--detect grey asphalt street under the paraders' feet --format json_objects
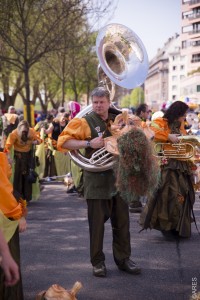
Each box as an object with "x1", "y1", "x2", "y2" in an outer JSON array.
[{"x1": 20, "y1": 183, "x2": 200, "y2": 300}]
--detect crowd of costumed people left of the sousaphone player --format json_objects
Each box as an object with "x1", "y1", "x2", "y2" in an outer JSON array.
[{"x1": 0, "y1": 101, "x2": 81, "y2": 300}]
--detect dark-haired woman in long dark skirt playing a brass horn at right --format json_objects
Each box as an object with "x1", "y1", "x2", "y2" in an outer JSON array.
[{"x1": 140, "y1": 101, "x2": 195, "y2": 237}]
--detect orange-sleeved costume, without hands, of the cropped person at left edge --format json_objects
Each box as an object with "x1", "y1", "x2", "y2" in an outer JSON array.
[{"x1": 0, "y1": 152, "x2": 26, "y2": 300}]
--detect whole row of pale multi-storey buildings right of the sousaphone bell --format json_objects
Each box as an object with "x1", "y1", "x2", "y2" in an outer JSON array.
[{"x1": 145, "y1": 0, "x2": 200, "y2": 110}]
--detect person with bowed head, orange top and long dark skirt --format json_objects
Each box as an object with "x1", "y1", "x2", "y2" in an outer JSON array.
[{"x1": 4, "y1": 120, "x2": 42, "y2": 201}]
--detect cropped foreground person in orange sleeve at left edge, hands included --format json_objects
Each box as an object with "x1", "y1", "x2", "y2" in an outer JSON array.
[{"x1": 0, "y1": 152, "x2": 27, "y2": 300}]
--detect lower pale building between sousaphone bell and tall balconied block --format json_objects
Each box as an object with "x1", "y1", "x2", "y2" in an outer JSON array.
[{"x1": 144, "y1": 34, "x2": 180, "y2": 110}]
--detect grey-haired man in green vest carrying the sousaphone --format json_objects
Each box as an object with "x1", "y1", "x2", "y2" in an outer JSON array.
[{"x1": 58, "y1": 87, "x2": 141, "y2": 277}]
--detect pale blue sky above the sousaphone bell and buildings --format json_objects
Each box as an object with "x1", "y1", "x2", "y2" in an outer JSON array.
[{"x1": 100, "y1": 0, "x2": 182, "y2": 60}]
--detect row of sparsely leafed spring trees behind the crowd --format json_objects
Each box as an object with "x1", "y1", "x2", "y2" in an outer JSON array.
[{"x1": 0, "y1": 0, "x2": 115, "y2": 123}]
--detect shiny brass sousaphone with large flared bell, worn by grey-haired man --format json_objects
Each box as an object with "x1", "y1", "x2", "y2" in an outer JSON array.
[{"x1": 69, "y1": 23, "x2": 149, "y2": 172}]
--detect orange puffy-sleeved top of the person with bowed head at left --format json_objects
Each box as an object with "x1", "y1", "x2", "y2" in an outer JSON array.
[{"x1": 4, "y1": 128, "x2": 42, "y2": 152}]
